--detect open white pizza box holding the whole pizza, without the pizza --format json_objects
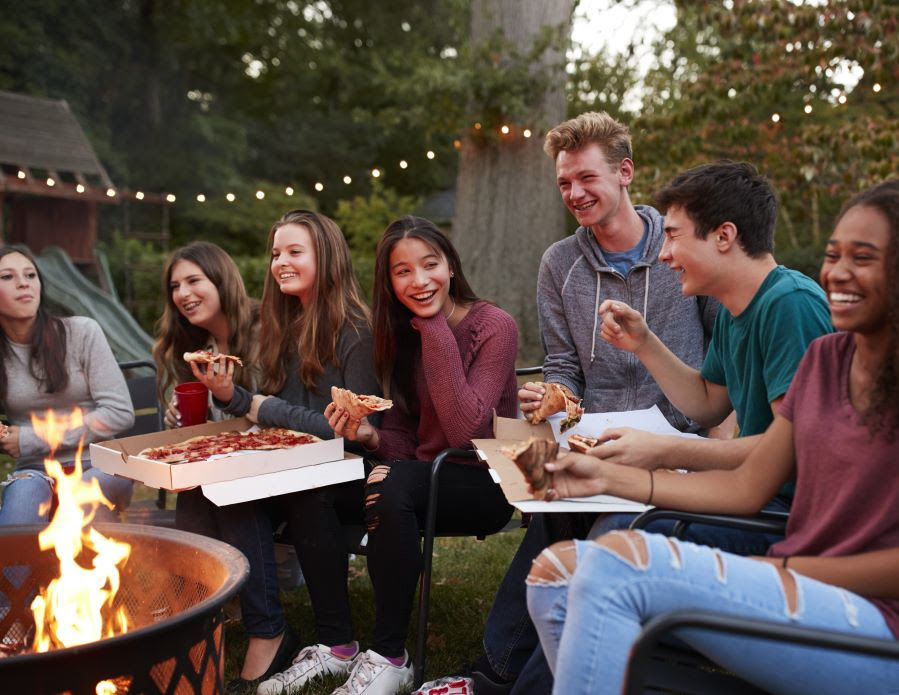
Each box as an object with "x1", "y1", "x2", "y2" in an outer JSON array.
[{"x1": 91, "y1": 418, "x2": 344, "y2": 492}]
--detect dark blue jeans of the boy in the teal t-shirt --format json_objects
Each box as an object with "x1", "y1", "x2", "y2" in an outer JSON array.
[{"x1": 484, "y1": 497, "x2": 789, "y2": 695}]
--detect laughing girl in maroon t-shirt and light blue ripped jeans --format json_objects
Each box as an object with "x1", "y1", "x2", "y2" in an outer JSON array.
[{"x1": 528, "y1": 180, "x2": 899, "y2": 695}]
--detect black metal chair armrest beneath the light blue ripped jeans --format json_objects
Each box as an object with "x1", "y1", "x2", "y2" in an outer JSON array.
[{"x1": 625, "y1": 611, "x2": 899, "y2": 695}]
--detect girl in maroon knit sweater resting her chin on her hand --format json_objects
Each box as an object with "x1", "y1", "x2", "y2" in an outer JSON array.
[{"x1": 325, "y1": 216, "x2": 518, "y2": 695}]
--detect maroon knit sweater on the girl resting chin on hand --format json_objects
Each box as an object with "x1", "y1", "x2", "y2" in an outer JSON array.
[{"x1": 376, "y1": 301, "x2": 518, "y2": 468}]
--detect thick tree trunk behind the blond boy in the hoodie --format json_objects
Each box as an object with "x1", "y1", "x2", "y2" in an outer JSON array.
[{"x1": 453, "y1": 0, "x2": 575, "y2": 364}]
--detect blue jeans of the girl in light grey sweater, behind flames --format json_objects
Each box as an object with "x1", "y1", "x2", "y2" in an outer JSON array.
[{"x1": 0, "y1": 462, "x2": 133, "y2": 526}]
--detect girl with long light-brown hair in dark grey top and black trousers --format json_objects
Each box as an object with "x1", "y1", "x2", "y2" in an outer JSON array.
[{"x1": 194, "y1": 210, "x2": 380, "y2": 693}]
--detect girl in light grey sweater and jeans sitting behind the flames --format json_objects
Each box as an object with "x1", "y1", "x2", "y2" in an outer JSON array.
[{"x1": 0, "y1": 246, "x2": 134, "y2": 525}]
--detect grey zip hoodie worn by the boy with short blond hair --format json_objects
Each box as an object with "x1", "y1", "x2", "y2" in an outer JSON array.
[{"x1": 537, "y1": 205, "x2": 718, "y2": 431}]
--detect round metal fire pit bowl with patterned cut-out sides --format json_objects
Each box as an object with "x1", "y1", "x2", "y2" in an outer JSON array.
[{"x1": 0, "y1": 524, "x2": 248, "y2": 695}]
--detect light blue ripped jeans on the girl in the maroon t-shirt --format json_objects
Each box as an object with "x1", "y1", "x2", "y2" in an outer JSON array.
[{"x1": 528, "y1": 531, "x2": 899, "y2": 695}]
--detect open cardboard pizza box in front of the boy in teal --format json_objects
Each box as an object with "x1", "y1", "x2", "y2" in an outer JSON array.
[{"x1": 472, "y1": 412, "x2": 650, "y2": 514}]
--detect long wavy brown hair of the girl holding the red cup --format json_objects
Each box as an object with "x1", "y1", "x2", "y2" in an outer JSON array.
[{"x1": 153, "y1": 241, "x2": 259, "y2": 400}]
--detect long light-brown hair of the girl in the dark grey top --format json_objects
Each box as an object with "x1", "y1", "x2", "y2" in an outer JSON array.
[{"x1": 259, "y1": 210, "x2": 371, "y2": 393}]
